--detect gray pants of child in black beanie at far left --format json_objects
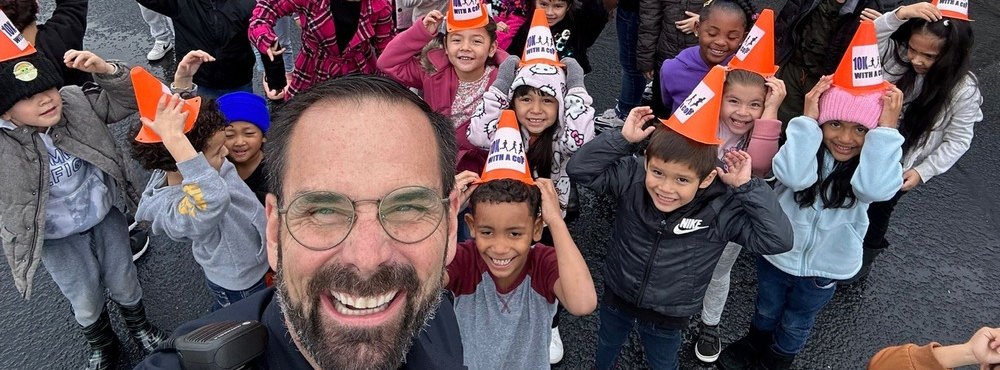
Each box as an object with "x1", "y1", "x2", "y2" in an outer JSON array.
[{"x1": 42, "y1": 207, "x2": 142, "y2": 326}]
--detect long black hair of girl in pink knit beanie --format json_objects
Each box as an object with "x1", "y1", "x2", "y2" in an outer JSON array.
[{"x1": 795, "y1": 146, "x2": 861, "y2": 208}]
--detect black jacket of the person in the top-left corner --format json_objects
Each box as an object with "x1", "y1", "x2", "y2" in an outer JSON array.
[{"x1": 35, "y1": 0, "x2": 94, "y2": 86}]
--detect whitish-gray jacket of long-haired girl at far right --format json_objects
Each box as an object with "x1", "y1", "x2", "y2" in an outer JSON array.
[{"x1": 875, "y1": 10, "x2": 983, "y2": 183}]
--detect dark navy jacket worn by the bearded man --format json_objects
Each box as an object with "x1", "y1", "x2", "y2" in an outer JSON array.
[{"x1": 135, "y1": 288, "x2": 465, "y2": 370}]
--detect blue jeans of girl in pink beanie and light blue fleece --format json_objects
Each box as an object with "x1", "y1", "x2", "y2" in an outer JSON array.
[{"x1": 752, "y1": 256, "x2": 837, "y2": 355}]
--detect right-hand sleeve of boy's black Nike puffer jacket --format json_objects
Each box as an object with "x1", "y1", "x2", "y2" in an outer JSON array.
[{"x1": 724, "y1": 177, "x2": 794, "y2": 254}]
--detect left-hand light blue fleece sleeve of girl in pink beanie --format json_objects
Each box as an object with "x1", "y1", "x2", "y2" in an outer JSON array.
[{"x1": 771, "y1": 116, "x2": 823, "y2": 191}]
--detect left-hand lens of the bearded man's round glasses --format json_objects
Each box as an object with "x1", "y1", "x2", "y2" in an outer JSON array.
[{"x1": 285, "y1": 192, "x2": 354, "y2": 250}]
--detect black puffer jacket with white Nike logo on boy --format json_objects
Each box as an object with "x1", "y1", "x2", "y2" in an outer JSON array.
[{"x1": 567, "y1": 132, "x2": 793, "y2": 317}]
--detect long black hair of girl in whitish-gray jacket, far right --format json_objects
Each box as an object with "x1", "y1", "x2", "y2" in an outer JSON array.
[{"x1": 883, "y1": 18, "x2": 975, "y2": 153}]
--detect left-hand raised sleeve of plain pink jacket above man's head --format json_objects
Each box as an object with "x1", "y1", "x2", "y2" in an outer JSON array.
[{"x1": 377, "y1": 23, "x2": 435, "y2": 89}]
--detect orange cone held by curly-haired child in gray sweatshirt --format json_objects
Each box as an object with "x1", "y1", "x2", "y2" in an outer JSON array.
[{"x1": 130, "y1": 67, "x2": 201, "y2": 143}]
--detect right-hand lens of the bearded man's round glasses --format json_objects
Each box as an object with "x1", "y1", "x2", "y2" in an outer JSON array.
[{"x1": 379, "y1": 187, "x2": 444, "y2": 243}]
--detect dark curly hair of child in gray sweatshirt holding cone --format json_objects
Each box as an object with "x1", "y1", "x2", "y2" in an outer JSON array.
[{"x1": 129, "y1": 99, "x2": 228, "y2": 171}]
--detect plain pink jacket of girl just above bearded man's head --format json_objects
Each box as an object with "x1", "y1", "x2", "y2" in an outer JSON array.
[{"x1": 377, "y1": 23, "x2": 507, "y2": 173}]
